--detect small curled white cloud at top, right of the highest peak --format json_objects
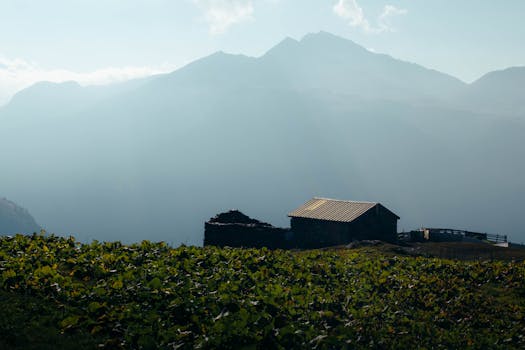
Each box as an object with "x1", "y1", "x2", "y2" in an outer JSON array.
[{"x1": 333, "y1": 0, "x2": 407, "y2": 34}]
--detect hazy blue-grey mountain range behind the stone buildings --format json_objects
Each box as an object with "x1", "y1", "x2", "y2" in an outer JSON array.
[{"x1": 0, "y1": 32, "x2": 525, "y2": 244}]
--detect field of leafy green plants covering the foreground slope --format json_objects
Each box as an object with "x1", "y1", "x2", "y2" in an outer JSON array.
[{"x1": 0, "y1": 235, "x2": 525, "y2": 349}]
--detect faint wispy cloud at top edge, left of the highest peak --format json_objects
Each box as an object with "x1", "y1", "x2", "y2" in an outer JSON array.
[{"x1": 193, "y1": 0, "x2": 253, "y2": 35}]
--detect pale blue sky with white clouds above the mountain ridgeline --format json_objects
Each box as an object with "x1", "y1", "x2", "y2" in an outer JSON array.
[{"x1": 0, "y1": 0, "x2": 525, "y2": 105}]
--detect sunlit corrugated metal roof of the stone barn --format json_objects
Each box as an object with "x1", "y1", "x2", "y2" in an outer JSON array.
[{"x1": 288, "y1": 197, "x2": 384, "y2": 222}]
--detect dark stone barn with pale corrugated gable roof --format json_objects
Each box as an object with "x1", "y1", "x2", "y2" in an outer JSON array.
[{"x1": 288, "y1": 198, "x2": 399, "y2": 249}]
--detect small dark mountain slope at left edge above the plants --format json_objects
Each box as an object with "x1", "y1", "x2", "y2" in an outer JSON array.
[{"x1": 0, "y1": 198, "x2": 40, "y2": 234}]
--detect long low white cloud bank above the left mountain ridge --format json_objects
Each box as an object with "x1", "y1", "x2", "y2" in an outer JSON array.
[{"x1": 0, "y1": 55, "x2": 175, "y2": 106}]
